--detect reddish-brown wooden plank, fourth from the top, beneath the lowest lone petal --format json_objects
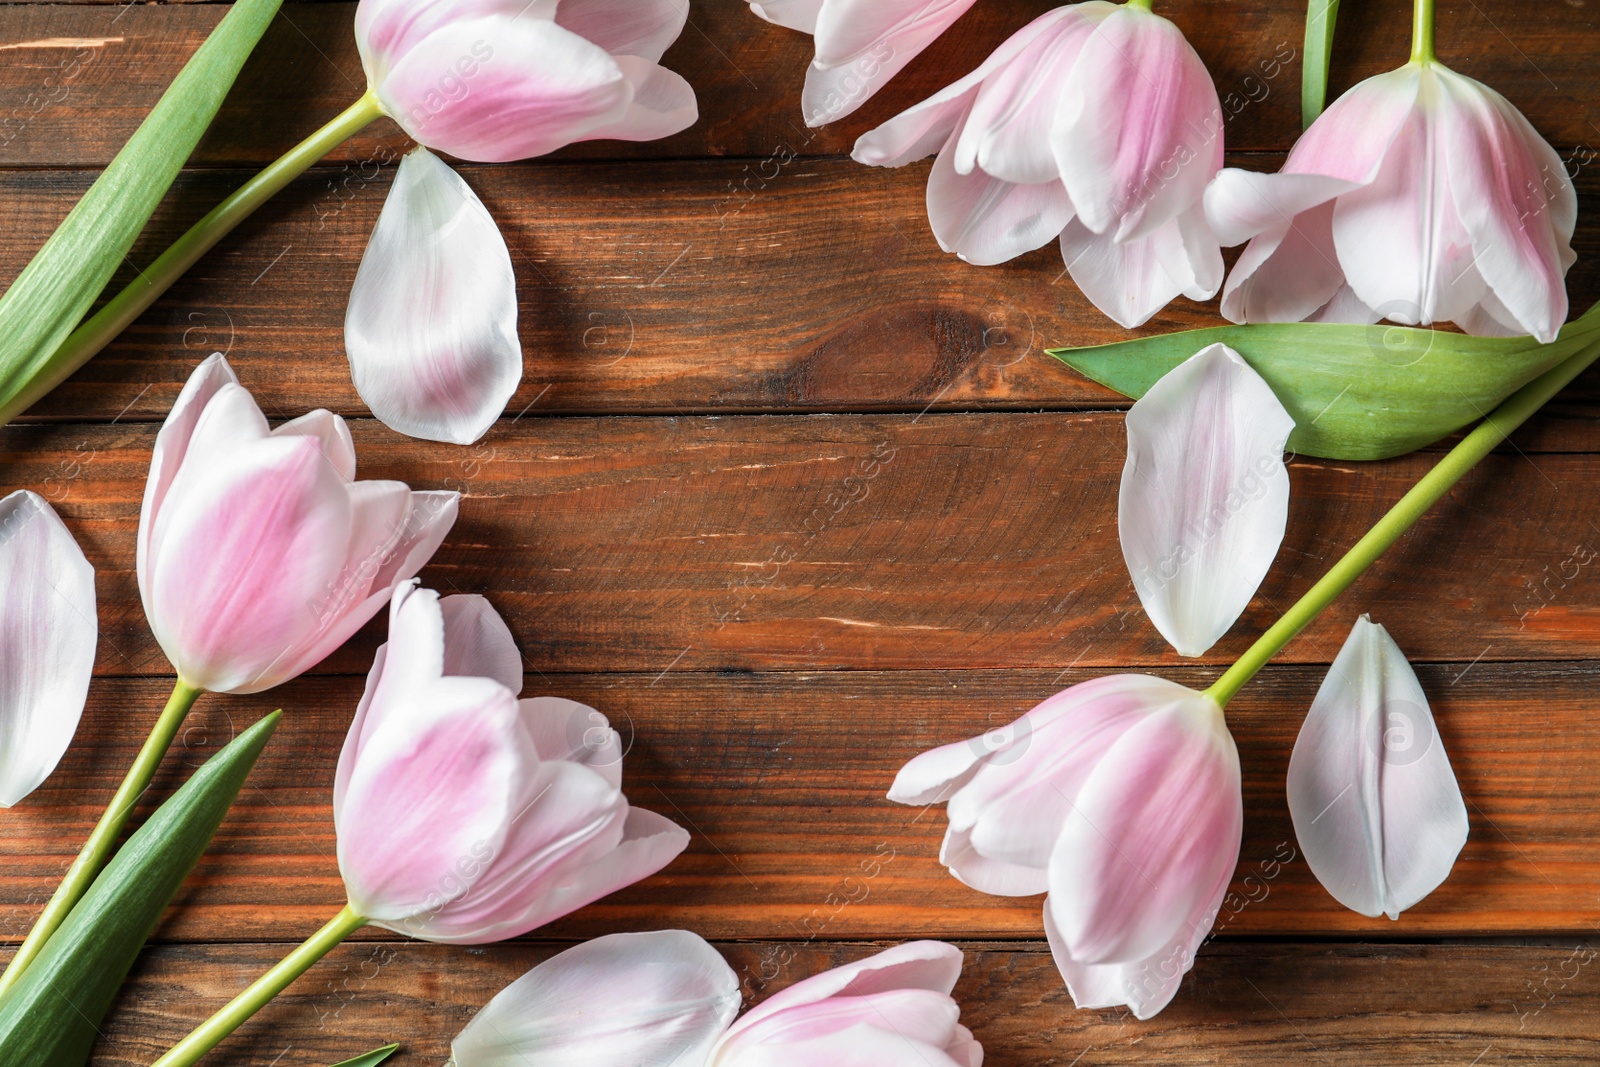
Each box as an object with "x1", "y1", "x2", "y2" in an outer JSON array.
[{"x1": 0, "y1": 661, "x2": 1600, "y2": 942}]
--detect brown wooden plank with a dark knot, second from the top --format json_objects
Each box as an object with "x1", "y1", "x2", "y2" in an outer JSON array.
[{"x1": 0, "y1": 164, "x2": 1600, "y2": 421}]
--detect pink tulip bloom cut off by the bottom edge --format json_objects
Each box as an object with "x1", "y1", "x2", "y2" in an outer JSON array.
[{"x1": 706, "y1": 941, "x2": 984, "y2": 1067}]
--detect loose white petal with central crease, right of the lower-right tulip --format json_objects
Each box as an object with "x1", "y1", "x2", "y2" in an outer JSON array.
[{"x1": 1288, "y1": 616, "x2": 1467, "y2": 918}]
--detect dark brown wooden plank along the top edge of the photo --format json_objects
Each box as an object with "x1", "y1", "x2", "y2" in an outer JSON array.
[{"x1": 0, "y1": 0, "x2": 1600, "y2": 166}]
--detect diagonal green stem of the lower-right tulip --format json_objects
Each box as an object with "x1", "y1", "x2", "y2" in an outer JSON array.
[{"x1": 1206, "y1": 342, "x2": 1600, "y2": 707}]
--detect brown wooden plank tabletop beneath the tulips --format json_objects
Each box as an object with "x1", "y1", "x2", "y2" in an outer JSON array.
[{"x1": 0, "y1": 0, "x2": 1600, "y2": 1067}]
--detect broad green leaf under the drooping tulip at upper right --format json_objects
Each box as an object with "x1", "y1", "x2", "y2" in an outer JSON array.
[{"x1": 1048, "y1": 306, "x2": 1600, "y2": 459}]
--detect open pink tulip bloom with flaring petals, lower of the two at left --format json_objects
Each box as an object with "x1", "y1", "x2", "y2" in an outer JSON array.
[{"x1": 333, "y1": 584, "x2": 688, "y2": 944}]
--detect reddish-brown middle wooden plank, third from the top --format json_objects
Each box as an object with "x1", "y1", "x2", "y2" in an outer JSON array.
[{"x1": 0, "y1": 412, "x2": 1600, "y2": 675}]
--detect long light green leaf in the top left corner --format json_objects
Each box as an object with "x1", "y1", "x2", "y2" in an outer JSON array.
[{"x1": 0, "y1": 0, "x2": 283, "y2": 422}]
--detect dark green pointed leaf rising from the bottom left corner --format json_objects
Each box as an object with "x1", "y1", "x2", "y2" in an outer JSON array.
[{"x1": 0, "y1": 712, "x2": 282, "y2": 1067}]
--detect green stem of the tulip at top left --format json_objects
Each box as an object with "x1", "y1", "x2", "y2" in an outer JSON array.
[{"x1": 0, "y1": 90, "x2": 382, "y2": 426}]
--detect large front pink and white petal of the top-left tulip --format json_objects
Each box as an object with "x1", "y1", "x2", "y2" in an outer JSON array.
[{"x1": 374, "y1": 18, "x2": 632, "y2": 163}]
